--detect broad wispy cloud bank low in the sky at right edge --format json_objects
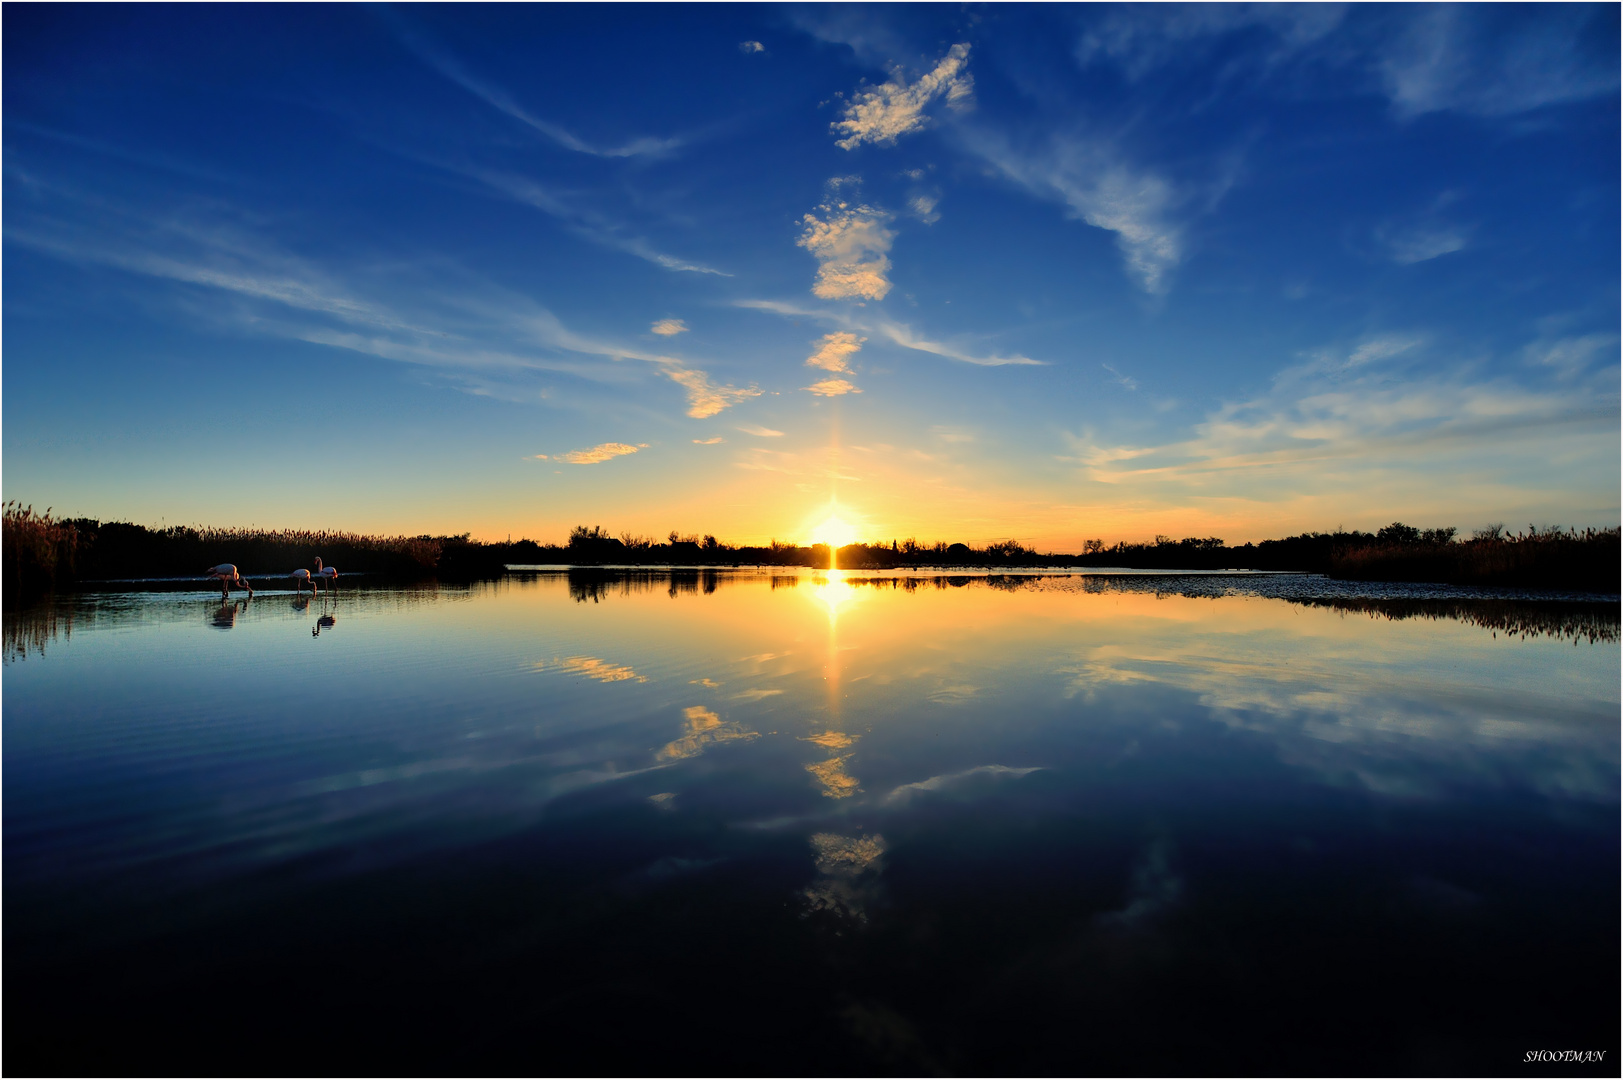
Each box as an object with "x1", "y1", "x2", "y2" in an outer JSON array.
[{"x1": 1068, "y1": 335, "x2": 1618, "y2": 528}]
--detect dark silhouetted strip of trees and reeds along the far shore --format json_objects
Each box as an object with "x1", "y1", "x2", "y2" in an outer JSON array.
[{"x1": 0, "y1": 502, "x2": 1620, "y2": 607}]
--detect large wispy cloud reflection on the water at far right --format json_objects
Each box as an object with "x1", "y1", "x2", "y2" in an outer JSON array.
[{"x1": 1068, "y1": 640, "x2": 1618, "y2": 799}]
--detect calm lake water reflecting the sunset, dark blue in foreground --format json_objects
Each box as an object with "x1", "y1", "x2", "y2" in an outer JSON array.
[{"x1": 3, "y1": 572, "x2": 1620, "y2": 1075}]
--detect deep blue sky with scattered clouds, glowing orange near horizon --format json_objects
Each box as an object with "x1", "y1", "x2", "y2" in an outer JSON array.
[{"x1": 0, "y1": 3, "x2": 1620, "y2": 551}]
